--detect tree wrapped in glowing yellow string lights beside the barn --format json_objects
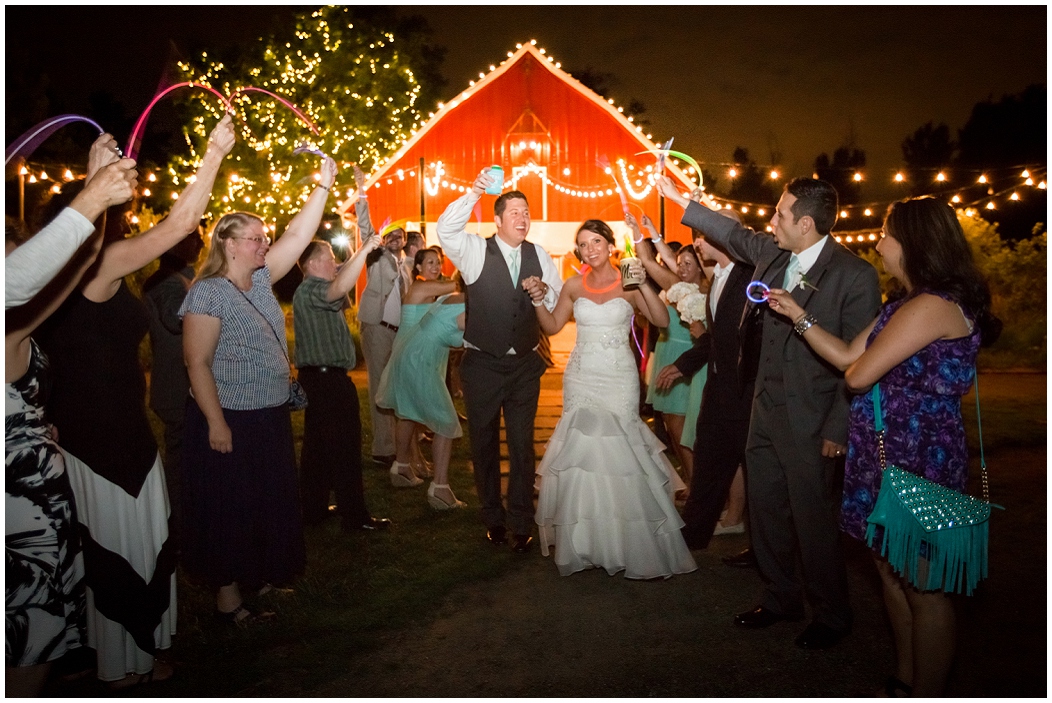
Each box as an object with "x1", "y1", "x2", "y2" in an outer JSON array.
[{"x1": 157, "y1": 7, "x2": 428, "y2": 227}]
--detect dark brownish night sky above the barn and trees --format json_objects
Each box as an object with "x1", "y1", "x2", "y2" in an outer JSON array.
[{"x1": 5, "y1": 5, "x2": 1047, "y2": 198}]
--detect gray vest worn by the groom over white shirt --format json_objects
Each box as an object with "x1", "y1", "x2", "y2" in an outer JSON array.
[{"x1": 464, "y1": 237, "x2": 542, "y2": 357}]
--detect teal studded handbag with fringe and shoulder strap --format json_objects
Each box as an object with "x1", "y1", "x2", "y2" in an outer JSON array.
[{"x1": 866, "y1": 378, "x2": 1000, "y2": 596}]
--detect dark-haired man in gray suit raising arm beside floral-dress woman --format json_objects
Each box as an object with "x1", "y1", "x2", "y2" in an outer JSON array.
[{"x1": 659, "y1": 178, "x2": 881, "y2": 649}]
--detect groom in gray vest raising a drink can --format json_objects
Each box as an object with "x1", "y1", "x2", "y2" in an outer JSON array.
[{"x1": 438, "y1": 168, "x2": 563, "y2": 553}]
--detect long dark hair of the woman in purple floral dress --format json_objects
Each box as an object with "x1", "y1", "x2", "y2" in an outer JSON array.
[{"x1": 884, "y1": 197, "x2": 1003, "y2": 346}]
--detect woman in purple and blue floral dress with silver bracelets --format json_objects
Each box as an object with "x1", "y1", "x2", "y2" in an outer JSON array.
[{"x1": 770, "y1": 198, "x2": 1000, "y2": 697}]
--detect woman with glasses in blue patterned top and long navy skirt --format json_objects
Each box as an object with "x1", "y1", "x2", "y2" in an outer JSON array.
[{"x1": 180, "y1": 158, "x2": 337, "y2": 624}]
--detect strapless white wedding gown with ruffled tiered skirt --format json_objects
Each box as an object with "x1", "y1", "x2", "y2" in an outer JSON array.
[{"x1": 537, "y1": 298, "x2": 697, "y2": 579}]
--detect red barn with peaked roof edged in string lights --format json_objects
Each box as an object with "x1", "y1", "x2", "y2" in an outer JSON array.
[{"x1": 343, "y1": 42, "x2": 696, "y2": 271}]
